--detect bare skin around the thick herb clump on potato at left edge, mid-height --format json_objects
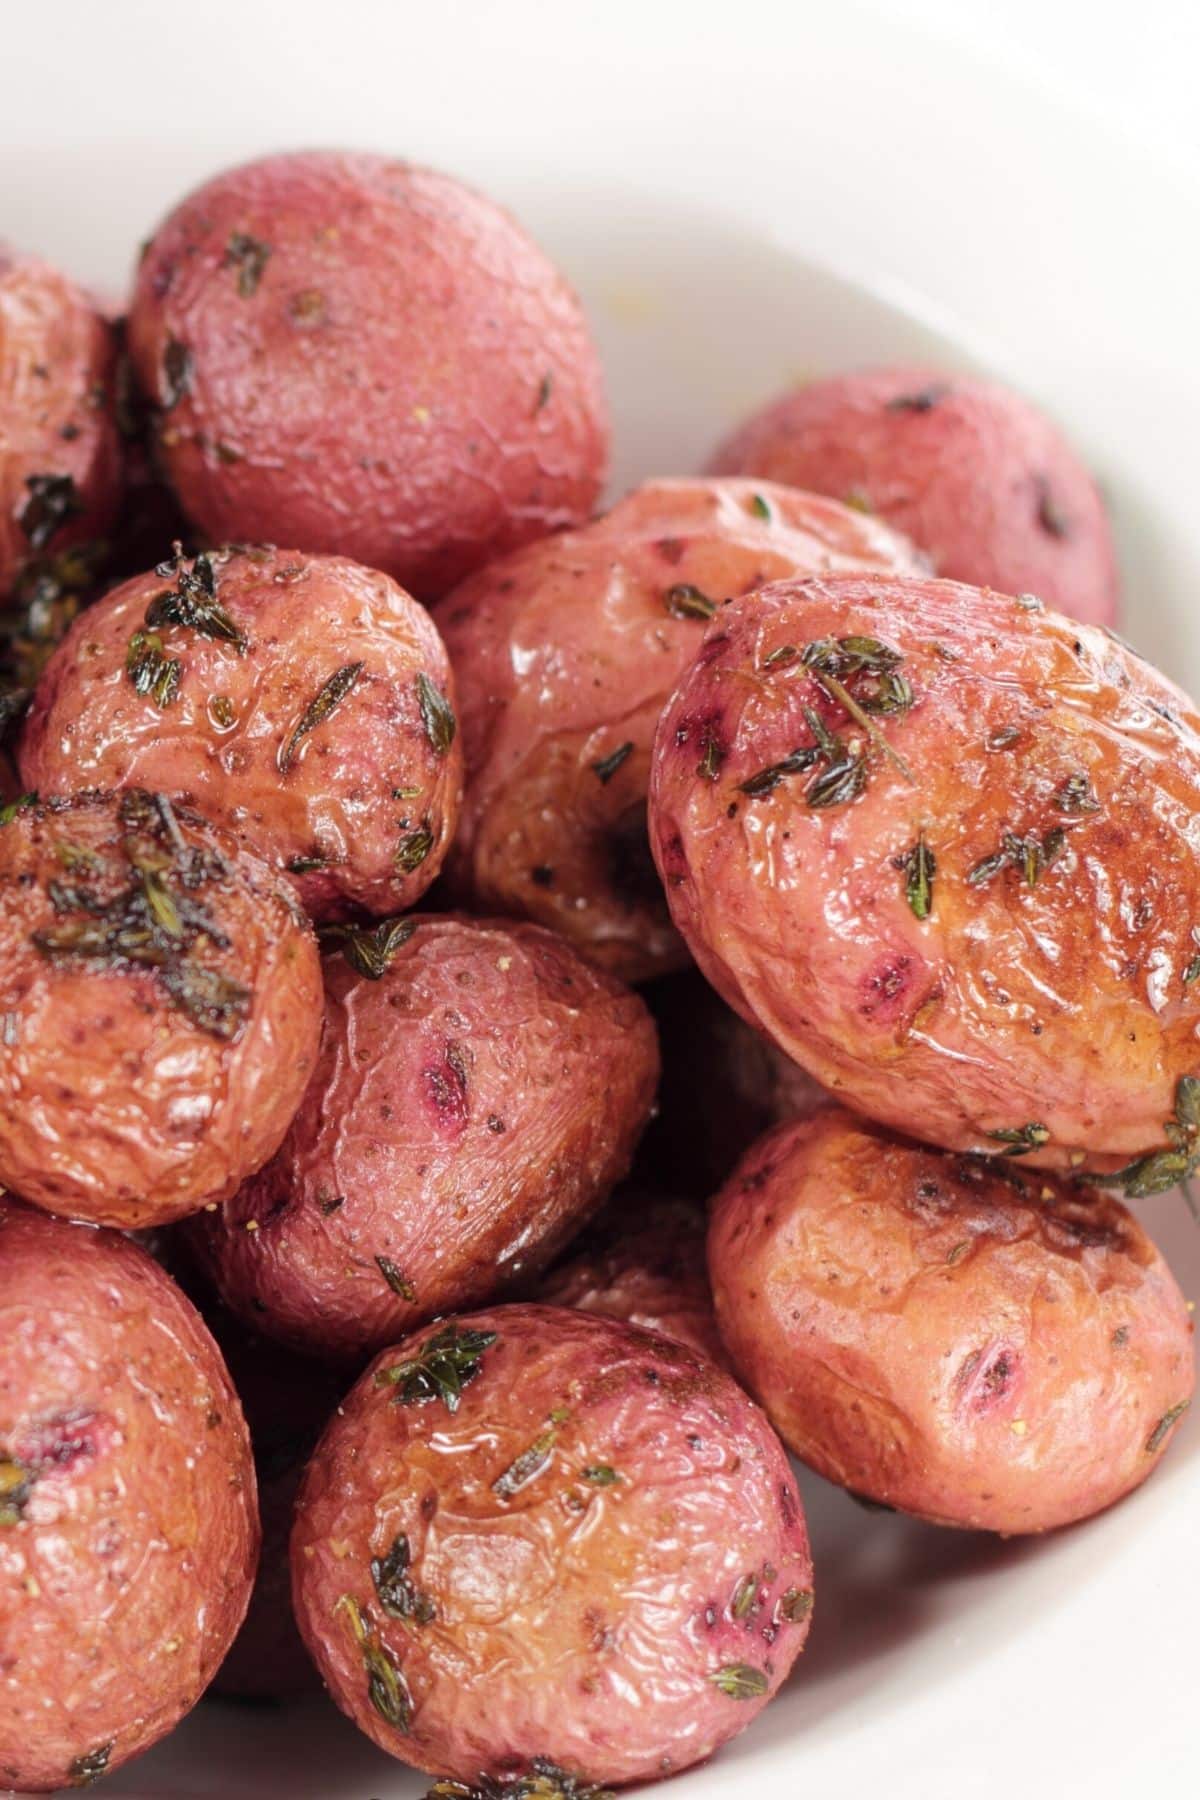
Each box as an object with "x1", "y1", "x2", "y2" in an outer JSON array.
[{"x1": 0, "y1": 794, "x2": 320, "y2": 1228}]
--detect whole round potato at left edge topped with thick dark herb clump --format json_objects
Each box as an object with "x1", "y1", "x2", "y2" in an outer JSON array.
[{"x1": 0, "y1": 788, "x2": 320, "y2": 1226}]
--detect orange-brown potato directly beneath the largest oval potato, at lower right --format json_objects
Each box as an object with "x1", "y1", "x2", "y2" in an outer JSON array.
[{"x1": 709, "y1": 1109, "x2": 1195, "y2": 1534}]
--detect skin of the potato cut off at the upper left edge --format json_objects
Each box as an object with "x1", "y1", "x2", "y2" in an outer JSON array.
[{"x1": 0, "y1": 245, "x2": 121, "y2": 601}]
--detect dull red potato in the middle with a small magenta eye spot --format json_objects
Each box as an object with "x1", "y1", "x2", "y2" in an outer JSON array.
[{"x1": 194, "y1": 914, "x2": 658, "y2": 1357}]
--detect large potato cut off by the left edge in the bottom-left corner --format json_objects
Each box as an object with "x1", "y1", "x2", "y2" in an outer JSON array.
[{"x1": 0, "y1": 1199, "x2": 259, "y2": 1793}]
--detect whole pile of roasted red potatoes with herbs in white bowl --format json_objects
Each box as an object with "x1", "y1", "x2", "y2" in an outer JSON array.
[{"x1": 0, "y1": 153, "x2": 1200, "y2": 1800}]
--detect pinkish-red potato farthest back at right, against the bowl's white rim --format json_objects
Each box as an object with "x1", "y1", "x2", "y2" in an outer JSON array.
[{"x1": 712, "y1": 365, "x2": 1119, "y2": 625}]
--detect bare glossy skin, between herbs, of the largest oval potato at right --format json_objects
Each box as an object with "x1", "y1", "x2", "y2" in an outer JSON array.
[{"x1": 651, "y1": 576, "x2": 1200, "y2": 1166}]
